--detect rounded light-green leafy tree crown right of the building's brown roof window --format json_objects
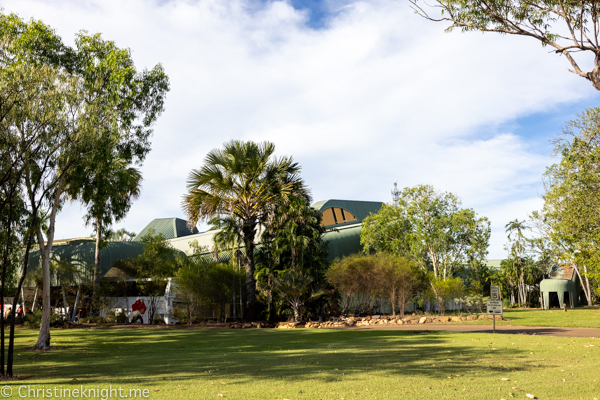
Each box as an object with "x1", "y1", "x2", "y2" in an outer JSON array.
[{"x1": 361, "y1": 185, "x2": 490, "y2": 280}]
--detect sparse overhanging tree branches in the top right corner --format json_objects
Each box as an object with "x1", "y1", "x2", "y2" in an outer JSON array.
[{"x1": 409, "y1": 0, "x2": 600, "y2": 90}]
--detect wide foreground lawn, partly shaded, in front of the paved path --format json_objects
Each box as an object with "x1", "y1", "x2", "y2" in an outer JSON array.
[{"x1": 8, "y1": 329, "x2": 600, "y2": 400}]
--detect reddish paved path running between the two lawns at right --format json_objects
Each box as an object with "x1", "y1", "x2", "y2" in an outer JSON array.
[{"x1": 342, "y1": 324, "x2": 600, "y2": 338}]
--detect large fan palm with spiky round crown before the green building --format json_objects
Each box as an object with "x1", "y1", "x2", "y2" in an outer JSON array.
[{"x1": 182, "y1": 140, "x2": 307, "y2": 319}]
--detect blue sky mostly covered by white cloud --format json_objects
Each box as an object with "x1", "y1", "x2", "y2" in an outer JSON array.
[{"x1": 0, "y1": 0, "x2": 600, "y2": 259}]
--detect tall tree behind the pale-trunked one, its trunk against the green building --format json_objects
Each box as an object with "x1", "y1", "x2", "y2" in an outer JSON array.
[{"x1": 68, "y1": 32, "x2": 169, "y2": 298}]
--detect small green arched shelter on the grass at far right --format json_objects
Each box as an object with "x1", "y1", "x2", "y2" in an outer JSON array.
[{"x1": 540, "y1": 264, "x2": 579, "y2": 310}]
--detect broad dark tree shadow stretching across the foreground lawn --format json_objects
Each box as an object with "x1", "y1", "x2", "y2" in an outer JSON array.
[{"x1": 9, "y1": 329, "x2": 530, "y2": 385}]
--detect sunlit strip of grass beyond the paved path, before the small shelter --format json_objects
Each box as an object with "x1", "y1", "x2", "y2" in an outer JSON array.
[{"x1": 462, "y1": 307, "x2": 600, "y2": 328}]
